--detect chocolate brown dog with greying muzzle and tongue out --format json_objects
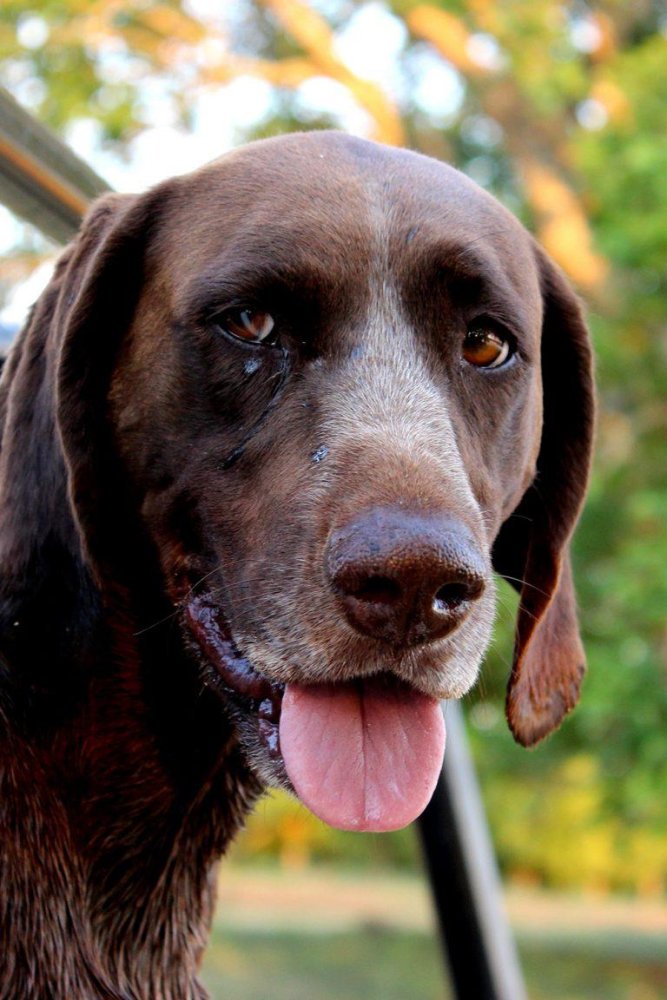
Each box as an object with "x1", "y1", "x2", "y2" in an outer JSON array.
[{"x1": 0, "y1": 132, "x2": 594, "y2": 1000}]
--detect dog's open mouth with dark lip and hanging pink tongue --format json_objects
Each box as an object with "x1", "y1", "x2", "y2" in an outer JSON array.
[{"x1": 185, "y1": 595, "x2": 445, "y2": 832}]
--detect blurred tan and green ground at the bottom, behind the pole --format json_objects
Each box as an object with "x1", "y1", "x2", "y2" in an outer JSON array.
[{"x1": 204, "y1": 865, "x2": 667, "y2": 1000}]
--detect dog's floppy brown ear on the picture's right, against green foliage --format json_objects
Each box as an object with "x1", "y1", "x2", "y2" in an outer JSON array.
[{"x1": 493, "y1": 247, "x2": 595, "y2": 746}]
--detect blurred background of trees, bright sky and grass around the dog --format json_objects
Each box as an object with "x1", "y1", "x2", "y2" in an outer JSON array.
[{"x1": 0, "y1": 0, "x2": 667, "y2": 1000}]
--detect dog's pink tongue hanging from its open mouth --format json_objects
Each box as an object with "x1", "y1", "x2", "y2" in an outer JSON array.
[{"x1": 280, "y1": 678, "x2": 445, "y2": 831}]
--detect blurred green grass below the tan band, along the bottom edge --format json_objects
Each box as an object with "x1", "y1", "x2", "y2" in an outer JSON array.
[{"x1": 204, "y1": 926, "x2": 667, "y2": 1000}]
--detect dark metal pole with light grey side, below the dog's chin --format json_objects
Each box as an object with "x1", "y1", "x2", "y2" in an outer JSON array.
[{"x1": 418, "y1": 702, "x2": 526, "y2": 1000}]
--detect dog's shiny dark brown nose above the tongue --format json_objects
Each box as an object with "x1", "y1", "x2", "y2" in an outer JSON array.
[{"x1": 325, "y1": 508, "x2": 486, "y2": 646}]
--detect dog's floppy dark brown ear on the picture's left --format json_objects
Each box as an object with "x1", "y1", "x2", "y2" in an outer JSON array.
[{"x1": 56, "y1": 188, "x2": 162, "y2": 583}]
